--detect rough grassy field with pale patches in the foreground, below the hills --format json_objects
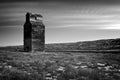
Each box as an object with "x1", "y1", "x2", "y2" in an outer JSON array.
[{"x1": 0, "y1": 51, "x2": 120, "y2": 80}]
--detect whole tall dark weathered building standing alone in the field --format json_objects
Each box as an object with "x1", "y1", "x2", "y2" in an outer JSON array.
[{"x1": 24, "y1": 12, "x2": 45, "y2": 52}]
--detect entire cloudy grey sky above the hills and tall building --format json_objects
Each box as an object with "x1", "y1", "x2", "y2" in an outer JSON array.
[{"x1": 0, "y1": 0, "x2": 120, "y2": 46}]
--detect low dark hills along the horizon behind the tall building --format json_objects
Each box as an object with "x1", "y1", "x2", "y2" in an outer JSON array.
[{"x1": 0, "y1": 38, "x2": 120, "y2": 51}]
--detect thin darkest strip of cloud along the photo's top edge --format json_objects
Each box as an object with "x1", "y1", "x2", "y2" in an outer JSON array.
[{"x1": 0, "y1": 0, "x2": 120, "y2": 4}]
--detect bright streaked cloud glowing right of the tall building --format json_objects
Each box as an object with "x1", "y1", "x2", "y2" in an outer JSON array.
[{"x1": 46, "y1": 6, "x2": 120, "y2": 30}]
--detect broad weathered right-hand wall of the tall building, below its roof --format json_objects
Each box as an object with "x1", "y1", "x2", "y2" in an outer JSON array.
[{"x1": 32, "y1": 22, "x2": 45, "y2": 51}]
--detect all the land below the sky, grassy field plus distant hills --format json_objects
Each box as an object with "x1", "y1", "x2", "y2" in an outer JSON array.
[{"x1": 0, "y1": 39, "x2": 120, "y2": 80}]
